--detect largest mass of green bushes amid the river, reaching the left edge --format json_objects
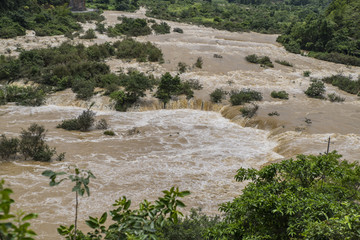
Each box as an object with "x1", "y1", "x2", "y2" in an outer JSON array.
[{"x1": 0, "y1": 38, "x2": 163, "y2": 102}]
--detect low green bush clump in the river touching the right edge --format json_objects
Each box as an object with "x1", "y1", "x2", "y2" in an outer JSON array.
[{"x1": 322, "y1": 74, "x2": 360, "y2": 94}]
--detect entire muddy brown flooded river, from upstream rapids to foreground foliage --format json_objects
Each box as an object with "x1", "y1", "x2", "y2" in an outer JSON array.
[{"x1": 0, "y1": 7, "x2": 360, "y2": 240}]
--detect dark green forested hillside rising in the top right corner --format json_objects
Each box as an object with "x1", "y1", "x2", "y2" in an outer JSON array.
[{"x1": 278, "y1": 0, "x2": 360, "y2": 66}]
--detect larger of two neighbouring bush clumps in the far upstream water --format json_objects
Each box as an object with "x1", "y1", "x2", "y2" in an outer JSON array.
[{"x1": 107, "y1": 17, "x2": 151, "y2": 37}]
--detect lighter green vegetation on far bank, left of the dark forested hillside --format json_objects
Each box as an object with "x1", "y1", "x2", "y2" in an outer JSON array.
[{"x1": 142, "y1": 0, "x2": 329, "y2": 33}]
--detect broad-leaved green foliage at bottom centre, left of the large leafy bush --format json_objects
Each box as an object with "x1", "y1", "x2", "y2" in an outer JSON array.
[{"x1": 58, "y1": 187, "x2": 190, "y2": 240}]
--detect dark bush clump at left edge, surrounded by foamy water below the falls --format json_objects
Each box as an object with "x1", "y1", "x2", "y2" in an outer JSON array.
[{"x1": 0, "y1": 124, "x2": 65, "y2": 162}]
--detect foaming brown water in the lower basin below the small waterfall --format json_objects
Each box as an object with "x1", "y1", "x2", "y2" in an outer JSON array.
[{"x1": 0, "y1": 106, "x2": 281, "y2": 239}]
